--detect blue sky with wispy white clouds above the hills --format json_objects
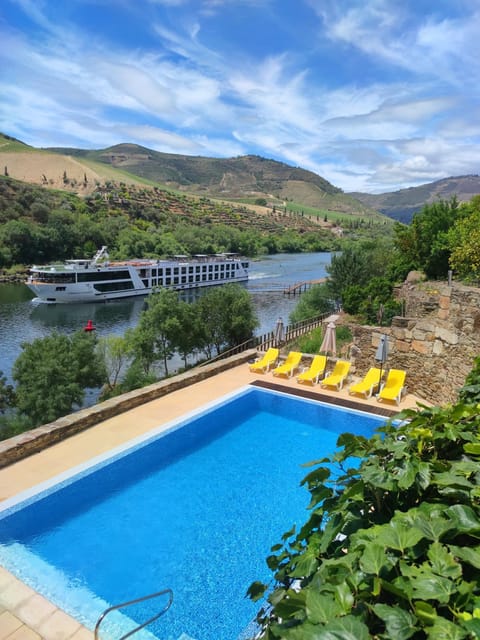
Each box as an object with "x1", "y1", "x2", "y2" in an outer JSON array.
[{"x1": 0, "y1": 0, "x2": 480, "y2": 193}]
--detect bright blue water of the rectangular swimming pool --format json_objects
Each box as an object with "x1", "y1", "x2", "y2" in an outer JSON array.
[{"x1": 0, "y1": 388, "x2": 384, "y2": 640}]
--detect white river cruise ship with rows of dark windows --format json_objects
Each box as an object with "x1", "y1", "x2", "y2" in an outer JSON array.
[{"x1": 26, "y1": 247, "x2": 249, "y2": 303}]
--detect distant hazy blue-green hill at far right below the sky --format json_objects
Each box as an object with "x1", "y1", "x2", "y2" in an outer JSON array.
[{"x1": 350, "y1": 175, "x2": 480, "y2": 223}]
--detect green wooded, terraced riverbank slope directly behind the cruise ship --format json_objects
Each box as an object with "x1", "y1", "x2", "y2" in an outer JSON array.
[{"x1": 0, "y1": 176, "x2": 339, "y2": 268}]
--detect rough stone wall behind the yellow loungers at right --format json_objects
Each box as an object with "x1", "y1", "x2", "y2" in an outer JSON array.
[{"x1": 351, "y1": 282, "x2": 480, "y2": 404}]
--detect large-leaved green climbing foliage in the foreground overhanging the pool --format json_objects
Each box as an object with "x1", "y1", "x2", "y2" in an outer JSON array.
[{"x1": 249, "y1": 384, "x2": 480, "y2": 640}]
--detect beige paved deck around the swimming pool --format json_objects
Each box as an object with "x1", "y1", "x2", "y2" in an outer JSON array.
[{"x1": 0, "y1": 364, "x2": 428, "y2": 640}]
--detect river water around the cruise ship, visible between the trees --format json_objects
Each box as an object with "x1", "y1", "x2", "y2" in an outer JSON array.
[{"x1": 0, "y1": 253, "x2": 331, "y2": 382}]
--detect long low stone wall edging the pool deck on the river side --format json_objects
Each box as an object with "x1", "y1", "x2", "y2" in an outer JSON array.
[{"x1": 0, "y1": 349, "x2": 257, "y2": 468}]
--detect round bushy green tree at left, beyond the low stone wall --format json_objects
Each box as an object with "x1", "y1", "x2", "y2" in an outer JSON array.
[{"x1": 12, "y1": 331, "x2": 104, "y2": 426}]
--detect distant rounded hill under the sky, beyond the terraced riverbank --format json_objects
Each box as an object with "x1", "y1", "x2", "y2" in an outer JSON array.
[{"x1": 48, "y1": 143, "x2": 378, "y2": 218}]
